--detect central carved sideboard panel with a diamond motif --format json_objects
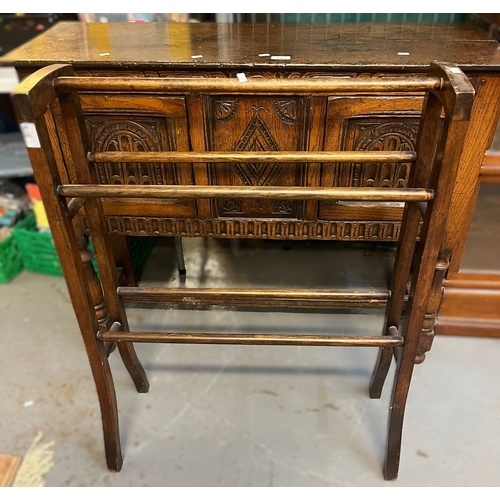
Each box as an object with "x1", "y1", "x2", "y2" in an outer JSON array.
[{"x1": 205, "y1": 96, "x2": 310, "y2": 218}]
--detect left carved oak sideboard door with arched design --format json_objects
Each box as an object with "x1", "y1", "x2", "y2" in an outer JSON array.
[{"x1": 82, "y1": 94, "x2": 196, "y2": 217}]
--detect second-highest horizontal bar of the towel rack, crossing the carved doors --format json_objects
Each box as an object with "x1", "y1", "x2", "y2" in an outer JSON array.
[{"x1": 87, "y1": 151, "x2": 417, "y2": 163}]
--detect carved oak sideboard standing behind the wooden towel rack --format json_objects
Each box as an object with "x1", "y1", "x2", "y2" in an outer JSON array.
[{"x1": 0, "y1": 22, "x2": 500, "y2": 336}]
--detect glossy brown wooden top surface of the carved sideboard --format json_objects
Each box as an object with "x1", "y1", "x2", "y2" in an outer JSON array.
[{"x1": 0, "y1": 22, "x2": 500, "y2": 71}]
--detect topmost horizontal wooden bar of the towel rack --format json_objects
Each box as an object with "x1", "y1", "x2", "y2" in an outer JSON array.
[{"x1": 54, "y1": 76, "x2": 442, "y2": 95}]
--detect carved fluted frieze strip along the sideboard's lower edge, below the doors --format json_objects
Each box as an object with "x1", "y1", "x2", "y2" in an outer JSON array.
[{"x1": 106, "y1": 216, "x2": 400, "y2": 241}]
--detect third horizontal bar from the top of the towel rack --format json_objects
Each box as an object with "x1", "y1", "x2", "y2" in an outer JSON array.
[{"x1": 57, "y1": 184, "x2": 434, "y2": 201}]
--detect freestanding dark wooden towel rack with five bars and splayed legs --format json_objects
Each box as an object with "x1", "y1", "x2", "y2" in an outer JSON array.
[{"x1": 13, "y1": 63, "x2": 474, "y2": 480}]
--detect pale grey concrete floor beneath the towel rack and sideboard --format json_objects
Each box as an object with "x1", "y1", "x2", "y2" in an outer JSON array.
[{"x1": 0, "y1": 239, "x2": 500, "y2": 486}]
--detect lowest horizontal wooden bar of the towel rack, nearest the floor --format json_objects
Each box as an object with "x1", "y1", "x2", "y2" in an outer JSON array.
[{"x1": 97, "y1": 331, "x2": 403, "y2": 347}]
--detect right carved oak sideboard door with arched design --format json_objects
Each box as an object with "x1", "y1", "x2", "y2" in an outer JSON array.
[{"x1": 320, "y1": 96, "x2": 423, "y2": 220}]
